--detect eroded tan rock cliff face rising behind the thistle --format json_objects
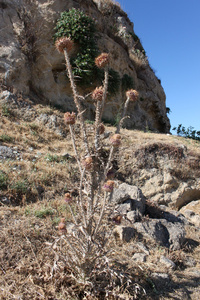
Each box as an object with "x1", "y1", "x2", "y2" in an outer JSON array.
[{"x1": 0, "y1": 0, "x2": 170, "y2": 133}]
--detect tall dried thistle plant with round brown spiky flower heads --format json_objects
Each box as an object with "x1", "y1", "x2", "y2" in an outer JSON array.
[{"x1": 56, "y1": 37, "x2": 138, "y2": 290}]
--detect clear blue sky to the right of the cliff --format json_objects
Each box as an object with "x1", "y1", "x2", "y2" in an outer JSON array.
[{"x1": 117, "y1": 0, "x2": 200, "y2": 133}]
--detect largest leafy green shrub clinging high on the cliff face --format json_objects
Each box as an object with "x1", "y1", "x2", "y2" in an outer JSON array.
[{"x1": 54, "y1": 8, "x2": 98, "y2": 84}]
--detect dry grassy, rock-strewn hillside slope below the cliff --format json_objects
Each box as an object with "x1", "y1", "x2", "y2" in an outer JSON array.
[{"x1": 0, "y1": 89, "x2": 200, "y2": 300}]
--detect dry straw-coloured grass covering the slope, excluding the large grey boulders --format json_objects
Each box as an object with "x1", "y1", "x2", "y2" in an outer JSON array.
[{"x1": 0, "y1": 100, "x2": 200, "y2": 300}]
